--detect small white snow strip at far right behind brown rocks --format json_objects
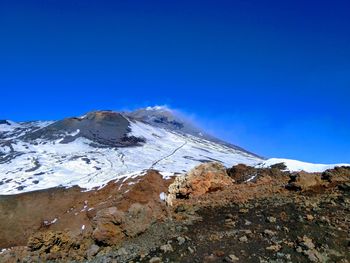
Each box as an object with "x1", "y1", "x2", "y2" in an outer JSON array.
[{"x1": 257, "y1": 158, "x2": 350, "y2": 173}]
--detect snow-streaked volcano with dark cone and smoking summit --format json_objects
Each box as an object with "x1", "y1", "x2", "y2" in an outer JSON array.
[{"x1": 0, "y1": 106, "x2": 264, "y2": 195}]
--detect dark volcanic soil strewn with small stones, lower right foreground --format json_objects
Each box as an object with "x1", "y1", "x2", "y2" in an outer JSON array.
[{"x1": 141, "y1": 194, "x2": 350, "y2": 263}]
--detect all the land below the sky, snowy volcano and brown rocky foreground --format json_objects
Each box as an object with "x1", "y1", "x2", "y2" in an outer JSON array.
[{"x1": 0, "y1": 106, "x2": 350, "y2": 263}]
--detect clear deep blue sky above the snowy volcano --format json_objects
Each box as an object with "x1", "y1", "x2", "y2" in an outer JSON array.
[{"x1": 0, "y1": 0, "x2": 350, "y2": 163}]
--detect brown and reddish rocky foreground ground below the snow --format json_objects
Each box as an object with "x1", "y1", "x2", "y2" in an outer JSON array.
[{"x1": 0, "y1": 163, "x2": 350, "y2": 263}]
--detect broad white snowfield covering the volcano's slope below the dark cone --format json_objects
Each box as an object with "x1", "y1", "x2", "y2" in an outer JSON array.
[{"x1": 0, "y1": 122, "x2": 262, "y2": 195}]
